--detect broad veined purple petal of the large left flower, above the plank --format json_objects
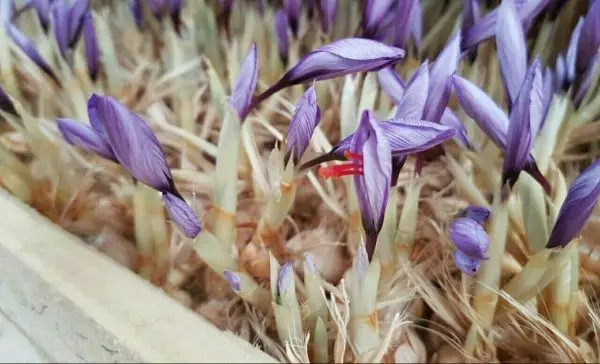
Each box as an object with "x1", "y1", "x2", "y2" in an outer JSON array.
[{"x1": 88, "y1": 94, "x2": 173, "y2": 191}]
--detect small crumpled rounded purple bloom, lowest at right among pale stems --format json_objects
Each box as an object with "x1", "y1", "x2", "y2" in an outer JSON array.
[{"x1": 449, "y1": 206, "x2": 490, "y2": 276}]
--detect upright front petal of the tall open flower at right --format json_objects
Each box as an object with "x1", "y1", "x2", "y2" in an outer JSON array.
[{"x1": 502, "y1": 57, "x2": 543, "y2": 187}]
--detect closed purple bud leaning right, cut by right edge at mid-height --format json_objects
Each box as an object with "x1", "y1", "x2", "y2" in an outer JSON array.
[{"x1": 546, "y1": 159, "x2": 600, "y2": 249}]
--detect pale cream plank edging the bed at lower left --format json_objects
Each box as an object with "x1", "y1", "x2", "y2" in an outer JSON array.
[{"x1": 0, "y1": 190, "x2": 276, "y2": 363}]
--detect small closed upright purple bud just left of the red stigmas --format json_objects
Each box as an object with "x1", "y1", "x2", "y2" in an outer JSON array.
[{"x1": 285, "y1": 86, "x2": 321, "y2": 165}]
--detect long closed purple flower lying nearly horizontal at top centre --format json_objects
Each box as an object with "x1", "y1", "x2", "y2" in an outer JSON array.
[{"x1": 249, "y1": 38, "x2": 404, "y2": 110}]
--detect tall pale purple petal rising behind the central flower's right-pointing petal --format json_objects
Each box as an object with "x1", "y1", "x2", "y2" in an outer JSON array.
[{"x1": 423, "y1": 32, "x2": 460, "y2": 123}]
